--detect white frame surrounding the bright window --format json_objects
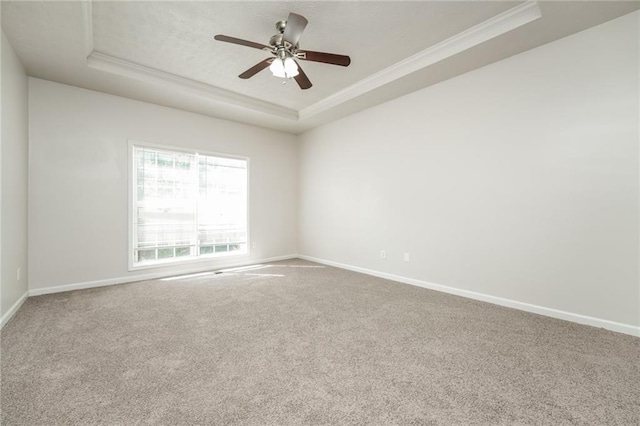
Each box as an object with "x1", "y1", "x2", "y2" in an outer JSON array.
[{"x1": 127, "y1": 139, "x2": 252, "y2": 271}]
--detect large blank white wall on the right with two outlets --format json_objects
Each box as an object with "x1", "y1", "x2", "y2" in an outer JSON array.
[{"x1": 299, "y1": 12, "x2": 640, "y2": 328}]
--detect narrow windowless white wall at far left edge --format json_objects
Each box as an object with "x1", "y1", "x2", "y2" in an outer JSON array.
[{"x1": 0, "y1": 31, "x2": 29, "y2": 325}]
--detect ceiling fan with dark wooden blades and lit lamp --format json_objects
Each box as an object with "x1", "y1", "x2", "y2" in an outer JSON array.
[{"x1": 214, "y1": 13, "x2": 351, "y2": 90}]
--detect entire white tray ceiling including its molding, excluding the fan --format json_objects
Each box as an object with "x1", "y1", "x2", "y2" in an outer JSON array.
[{"x1": 2, "y1": 1, "x2": 640, "y2": 133}]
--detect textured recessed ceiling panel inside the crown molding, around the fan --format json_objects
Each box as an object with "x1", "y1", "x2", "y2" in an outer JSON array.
[{"x1": 92, "y1": 2, "x2": 515, "y2": 109}]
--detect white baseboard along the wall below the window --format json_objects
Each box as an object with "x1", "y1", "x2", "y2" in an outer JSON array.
[{"x1": 29, "y1": 254, "x2": 298, "y2": 296}]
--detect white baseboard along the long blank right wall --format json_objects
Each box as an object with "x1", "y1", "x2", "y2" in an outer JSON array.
[{"x1": 298, "y1": 255, "x2": 640, "y2": 337}]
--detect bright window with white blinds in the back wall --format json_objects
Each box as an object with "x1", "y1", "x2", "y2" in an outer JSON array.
[{"x1": 131, "y1": 143, "x2": 247, "y2": 267}]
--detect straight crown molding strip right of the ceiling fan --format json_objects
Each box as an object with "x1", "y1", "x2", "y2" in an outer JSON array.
[{"x1": 299, "y1": 1, "x2": 542, "y2": 120}]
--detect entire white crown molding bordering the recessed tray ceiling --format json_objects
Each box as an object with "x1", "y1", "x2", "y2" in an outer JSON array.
[{"x1": 82, "y1": 0, "x2": 542, "y2": 122}]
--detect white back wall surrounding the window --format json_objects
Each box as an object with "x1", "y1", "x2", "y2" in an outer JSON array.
[{"x1": 29, "y1": 78, "x2": 298, "y2": 294}]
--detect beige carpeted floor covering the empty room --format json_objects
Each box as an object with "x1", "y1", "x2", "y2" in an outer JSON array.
[{"x1": 1, "y1": 260, "x2": 640, "y2": 425}]
